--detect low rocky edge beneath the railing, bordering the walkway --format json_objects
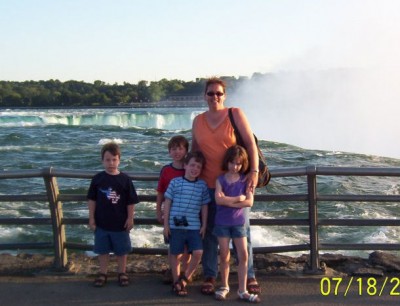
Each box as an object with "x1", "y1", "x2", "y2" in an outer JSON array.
[{"x1": 0, "y1": 251, "x2": 400, "y2": 278}]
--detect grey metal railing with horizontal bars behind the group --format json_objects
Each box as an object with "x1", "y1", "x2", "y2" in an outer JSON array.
[{"x1": 0, "y1": 166, "x2": 400, "y2": 273}]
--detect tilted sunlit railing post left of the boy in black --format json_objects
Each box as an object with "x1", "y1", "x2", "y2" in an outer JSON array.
[{"x1": 43, "y1": 167, "x2": 68, "y2": 268}]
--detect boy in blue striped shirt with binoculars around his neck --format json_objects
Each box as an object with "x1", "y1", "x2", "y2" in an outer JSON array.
[{"x1": 164, "y1": 152, "x2": 211, "y2": 296}]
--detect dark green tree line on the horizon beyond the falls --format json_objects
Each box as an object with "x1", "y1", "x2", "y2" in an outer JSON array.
[{"x1": 0, "y1": 75, "x2": 260, "y2": 107}]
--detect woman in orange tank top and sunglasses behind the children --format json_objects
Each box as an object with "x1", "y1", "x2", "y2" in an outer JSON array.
[{"x1": 192, "y1": 78, "x2": 260, "y2": 302}]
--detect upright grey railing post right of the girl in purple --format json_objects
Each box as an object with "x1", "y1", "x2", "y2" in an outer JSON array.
[{"x1": 307, "y1": 165, "x2": 320, "y2": 273}]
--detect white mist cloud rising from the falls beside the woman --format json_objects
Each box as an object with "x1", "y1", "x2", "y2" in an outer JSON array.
[{"x1": 228, "y1": 69, "x2": 400, "y2": 158}]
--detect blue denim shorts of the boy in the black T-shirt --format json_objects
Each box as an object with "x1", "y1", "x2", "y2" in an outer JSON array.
[{"x1": 93, "y1": 227, "x2": 132, "y2": 256}]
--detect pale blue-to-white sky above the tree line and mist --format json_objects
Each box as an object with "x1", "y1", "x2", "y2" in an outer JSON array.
[{"x1": 0, "y1": 0, "x2": 400, "y2": 84}]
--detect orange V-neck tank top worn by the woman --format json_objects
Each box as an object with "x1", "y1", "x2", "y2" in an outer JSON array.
[{"x1": 192, "y1": 113, "x2": 236, "y2": 188}]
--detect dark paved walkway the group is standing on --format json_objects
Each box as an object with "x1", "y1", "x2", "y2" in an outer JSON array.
[{"x1": 0, "y1": 274, "x2": 400, "y2": 306}]
